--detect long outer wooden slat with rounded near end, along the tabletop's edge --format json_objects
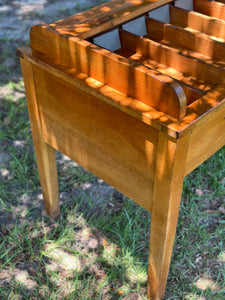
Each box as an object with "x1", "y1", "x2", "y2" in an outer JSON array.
[{"x1": 31, "y1": 26, "x2": 187, "y2": 119}]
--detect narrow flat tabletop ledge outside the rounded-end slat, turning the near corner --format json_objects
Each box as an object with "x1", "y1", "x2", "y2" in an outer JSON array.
[{"x1": 18, "y1": 46, "x2": 225, "y2": 139}]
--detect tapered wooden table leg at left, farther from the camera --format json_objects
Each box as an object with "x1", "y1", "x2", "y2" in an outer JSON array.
[{"x1": 20, "y1": 58, "x2": 60, "y2": 218}]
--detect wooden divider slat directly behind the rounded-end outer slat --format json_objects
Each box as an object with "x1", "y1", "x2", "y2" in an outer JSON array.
[{"x1": 120, "y1": 30, "x2": 224, "y2": 89}]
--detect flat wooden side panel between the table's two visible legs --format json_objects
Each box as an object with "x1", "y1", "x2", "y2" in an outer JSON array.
[{"x1": 34, "y1": 66, "x2": 158, "y2": 211}]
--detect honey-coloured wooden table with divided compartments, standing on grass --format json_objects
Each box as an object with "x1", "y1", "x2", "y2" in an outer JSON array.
[{"x1": 18, "y1": 0, "x2": 225, "y2": 300}]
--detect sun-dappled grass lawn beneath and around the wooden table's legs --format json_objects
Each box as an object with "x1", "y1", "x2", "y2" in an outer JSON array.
[{"x1": 0, "y1": 81, "x2": 225, "y2": 300}]
